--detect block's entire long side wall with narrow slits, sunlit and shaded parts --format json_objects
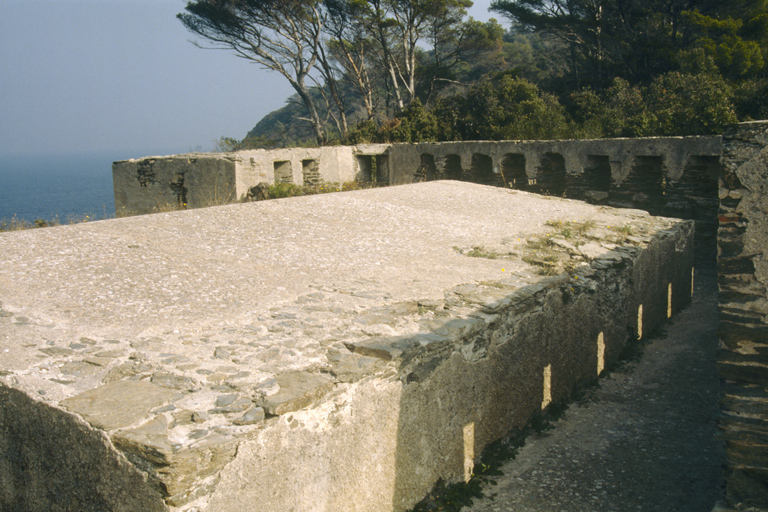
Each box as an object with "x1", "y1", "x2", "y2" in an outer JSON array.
[{"x1": 200, "y1": 222, "x2": 693, "y2": 512}]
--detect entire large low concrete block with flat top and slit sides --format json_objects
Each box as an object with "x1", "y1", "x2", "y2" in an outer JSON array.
[{"x1": 0, "y1": 182, "x2": 693, "y2": 512}]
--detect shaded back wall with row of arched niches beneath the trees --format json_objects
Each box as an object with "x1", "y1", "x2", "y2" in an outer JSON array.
[{"x1": 389, "y1": 137, "x2": 720, "y2": 269}]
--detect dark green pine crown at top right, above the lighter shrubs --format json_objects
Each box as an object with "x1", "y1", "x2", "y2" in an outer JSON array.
[{"x1": 492, "y1": 0, "x2": 720, "y2": 90}]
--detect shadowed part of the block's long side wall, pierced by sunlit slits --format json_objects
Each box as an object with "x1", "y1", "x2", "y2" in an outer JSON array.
[{"x1": 393, "y1": 226, "x2": 693, "y2": 511}]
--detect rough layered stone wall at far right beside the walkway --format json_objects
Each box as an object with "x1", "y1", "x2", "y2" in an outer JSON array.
[{"x1": 718, "y1": 121, "x2": 768, "y2": 510}]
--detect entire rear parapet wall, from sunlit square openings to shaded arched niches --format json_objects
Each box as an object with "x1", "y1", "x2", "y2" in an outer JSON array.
[{"x1": 113, "y1": 137, "x2": 720, "y2": 266}]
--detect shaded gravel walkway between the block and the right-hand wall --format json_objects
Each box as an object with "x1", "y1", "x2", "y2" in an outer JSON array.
[{"x1": 462, "y1": 274, "x2": 725, "y2": 512}]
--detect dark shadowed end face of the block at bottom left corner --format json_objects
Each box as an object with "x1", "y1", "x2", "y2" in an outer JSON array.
[{"x1": 0, "y1": 386, "x2": 167, "y2": 512}]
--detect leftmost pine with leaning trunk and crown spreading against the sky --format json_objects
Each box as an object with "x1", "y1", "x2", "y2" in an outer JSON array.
[{"x1": 177, "y1": 0, "x2": 327, "y2": 146}]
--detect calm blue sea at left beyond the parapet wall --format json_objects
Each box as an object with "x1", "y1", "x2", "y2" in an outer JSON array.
[{"x1": 0, "y1": 154, "x2": 124, "y2": 222}]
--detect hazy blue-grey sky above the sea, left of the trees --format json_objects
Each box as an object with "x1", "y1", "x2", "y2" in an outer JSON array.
[{"x1": 0, "y1": 0, "x2": 492, "y2": 159}]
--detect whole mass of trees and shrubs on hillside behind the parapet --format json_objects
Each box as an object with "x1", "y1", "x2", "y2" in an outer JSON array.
[{"x1": 180, "y1": 0, "x2": 768, "y2": 149}]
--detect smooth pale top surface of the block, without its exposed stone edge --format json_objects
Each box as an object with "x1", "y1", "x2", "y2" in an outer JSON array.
[{"x1": 0, "y1": 182, "x2": 660, "y2": 386}]
